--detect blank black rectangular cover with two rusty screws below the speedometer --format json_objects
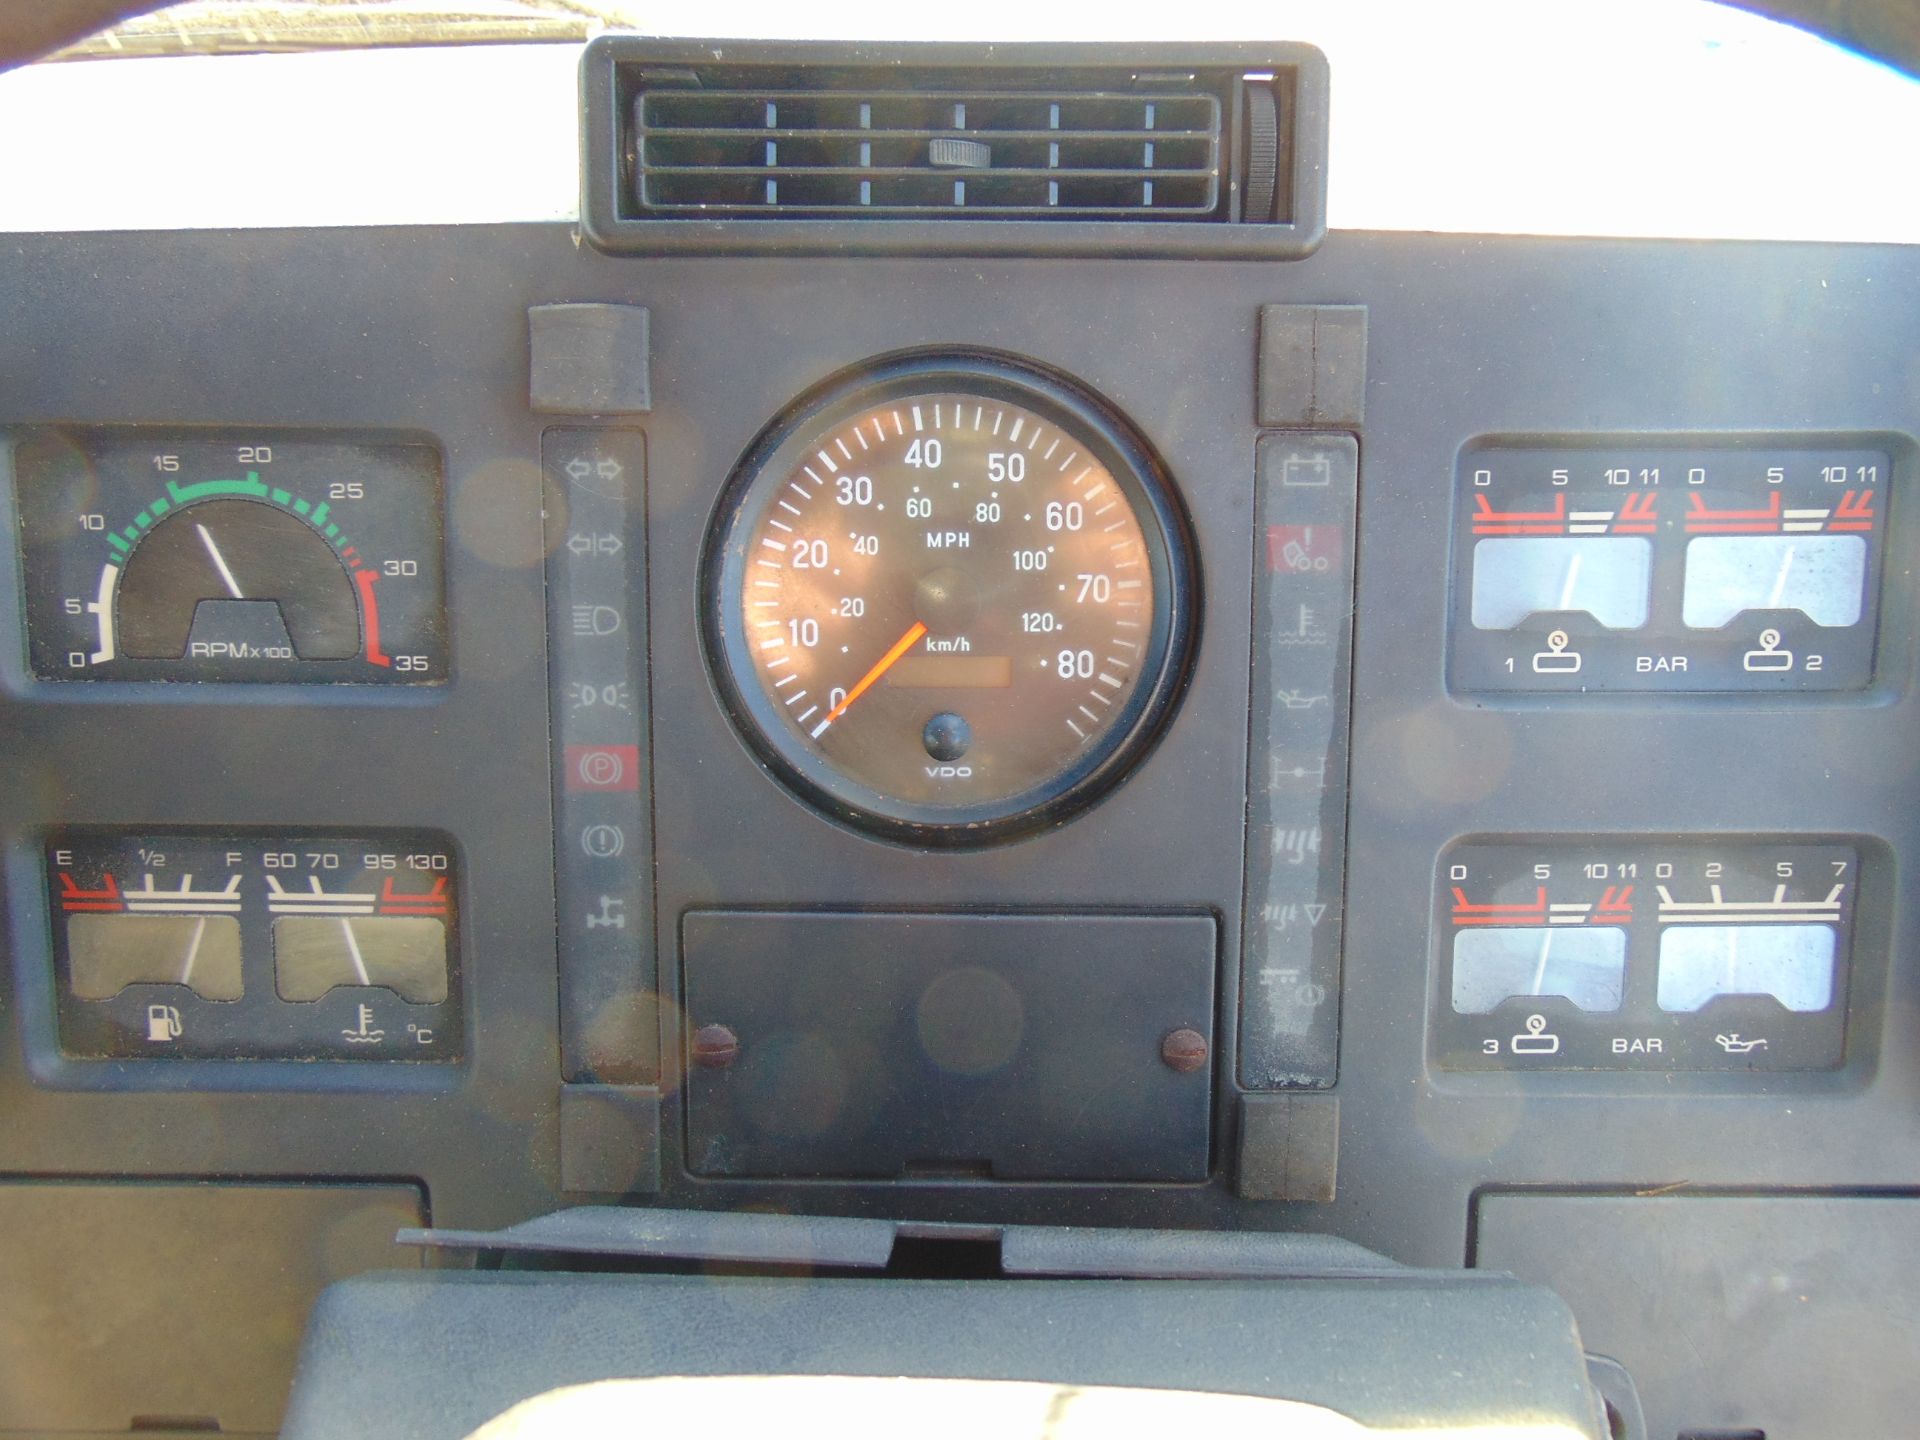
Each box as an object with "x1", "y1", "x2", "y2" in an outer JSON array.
[{"x1": 682, "y1": 910, "x2": 1215, "y2": 1183}]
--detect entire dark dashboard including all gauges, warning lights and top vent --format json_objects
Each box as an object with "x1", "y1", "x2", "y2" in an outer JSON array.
[{"x1": 0, "y1": 19, "x2": 1920, "y2": 1436}]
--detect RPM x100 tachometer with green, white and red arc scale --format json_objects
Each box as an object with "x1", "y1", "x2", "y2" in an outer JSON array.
[{"x1": 13, "y1": 426, "x2": 447, "y2": 685}]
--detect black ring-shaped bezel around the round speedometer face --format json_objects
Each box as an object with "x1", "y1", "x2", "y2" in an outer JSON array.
[{"x1": 701, "y1": 348, "x2": 1200, "y2": 849}]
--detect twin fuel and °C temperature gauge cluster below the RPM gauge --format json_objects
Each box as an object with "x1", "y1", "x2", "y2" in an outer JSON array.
[{"x1": 46, "y1": 829, "x2": 463, "y2": 1062}]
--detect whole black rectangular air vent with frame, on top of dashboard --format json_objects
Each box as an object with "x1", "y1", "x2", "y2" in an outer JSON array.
[{"x1": 582, "y1": 36, "x2": 1327, "y2": 257}]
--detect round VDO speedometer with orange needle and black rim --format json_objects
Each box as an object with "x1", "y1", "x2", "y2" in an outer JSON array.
[{"x1": 705, "y1": 353, "x2": 1194, "y2": 845}]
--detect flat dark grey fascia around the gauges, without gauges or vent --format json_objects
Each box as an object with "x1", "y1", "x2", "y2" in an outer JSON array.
[{"x1": 0, "y1": 225, "x2": 1920, "y2": 1440}]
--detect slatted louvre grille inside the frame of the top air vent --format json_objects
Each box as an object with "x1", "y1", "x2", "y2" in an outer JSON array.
[{"x1": 632, "y1": 86, "x2": 1227, "y2": 221}]
